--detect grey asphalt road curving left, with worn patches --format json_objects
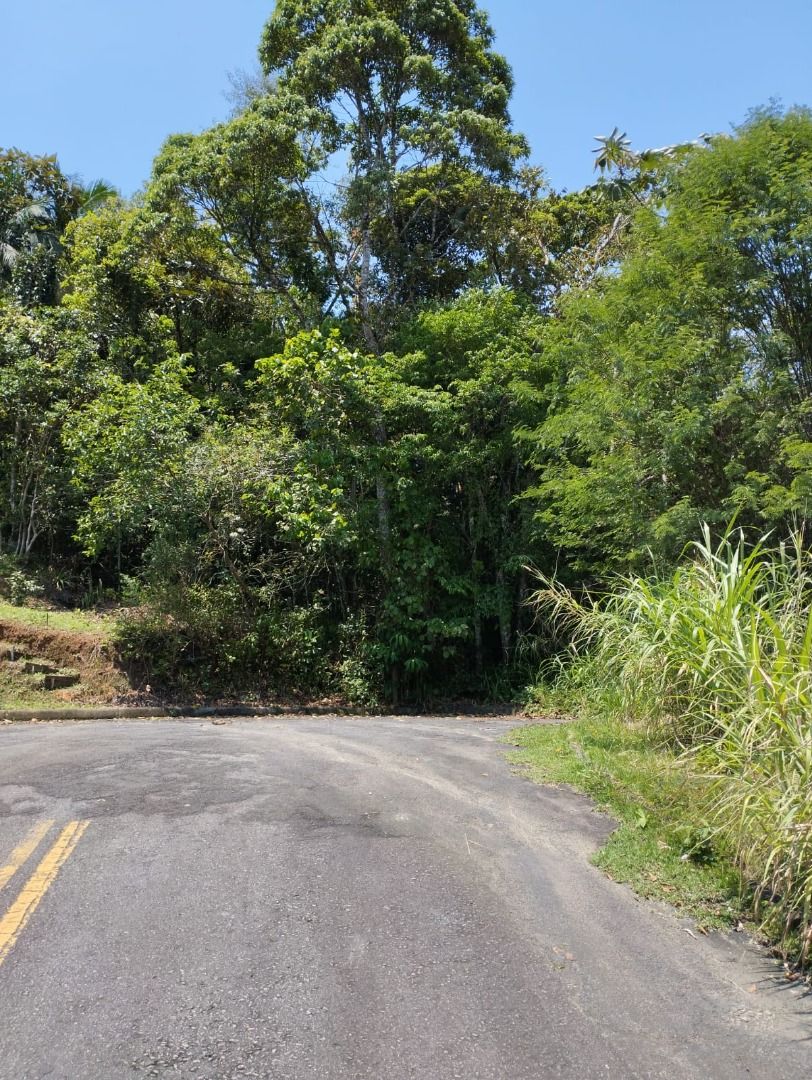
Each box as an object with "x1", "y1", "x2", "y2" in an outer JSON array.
[{"x1": 0, "y1": 718, "x2": 812, "y2": 1080}]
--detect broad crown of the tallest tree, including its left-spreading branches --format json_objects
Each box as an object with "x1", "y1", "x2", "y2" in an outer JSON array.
[{"x1": 149, "y1": 0, "x2": 527, "y2": 352}]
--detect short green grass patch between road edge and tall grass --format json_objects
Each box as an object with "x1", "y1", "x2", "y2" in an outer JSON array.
[{"x1": 509, "y1": 719, "x2": 746, "y2": 930}]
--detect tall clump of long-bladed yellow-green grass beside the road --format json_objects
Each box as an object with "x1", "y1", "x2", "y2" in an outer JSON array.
[{"x1": 534, "y1": 528, "x2": 812, "y2": 962}]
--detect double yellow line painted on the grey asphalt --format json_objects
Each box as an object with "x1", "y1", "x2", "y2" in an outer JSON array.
[{"x1": 0, "y1": 821, "x2": 90, "y2": 964}]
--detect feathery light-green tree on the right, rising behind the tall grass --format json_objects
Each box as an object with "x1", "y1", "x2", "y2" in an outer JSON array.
[{"x1": 522, "y1": 110, "x2": 812, "y2": 575}]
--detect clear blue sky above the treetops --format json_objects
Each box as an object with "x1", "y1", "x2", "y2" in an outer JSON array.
[{"x1": 0, "y1": 0, "x2": 812, "y2": 194}]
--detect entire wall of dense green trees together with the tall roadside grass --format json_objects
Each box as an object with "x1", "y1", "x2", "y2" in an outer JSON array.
[{"x1": 0, "y1": 0, "x2": 812, "y2": 963}]
